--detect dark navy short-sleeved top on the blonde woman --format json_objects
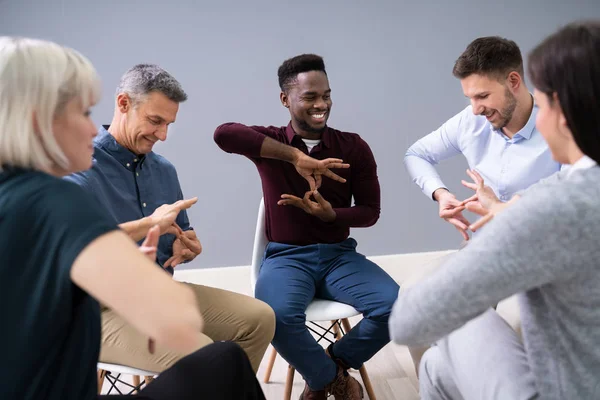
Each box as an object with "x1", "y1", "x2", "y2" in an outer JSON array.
[{"x1": 0, "y1": 169, "x2": 117, "y2": 400}]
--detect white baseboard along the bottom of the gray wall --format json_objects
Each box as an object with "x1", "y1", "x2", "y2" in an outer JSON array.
[{"x1": 175, "y1": 250, "x2": 455, "y2": 295}]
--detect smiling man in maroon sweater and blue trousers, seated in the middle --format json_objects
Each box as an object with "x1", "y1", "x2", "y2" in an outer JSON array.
[{"x1": 215, "y1": 54, "x2": 399, "y2": 399}]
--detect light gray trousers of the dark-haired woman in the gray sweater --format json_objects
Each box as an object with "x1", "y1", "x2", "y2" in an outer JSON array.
[{"x1": 419, "y1": 309, "x2": 537, "y2": 400}]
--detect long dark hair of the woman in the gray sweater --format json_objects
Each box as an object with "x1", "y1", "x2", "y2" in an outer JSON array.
[{"x1": 528, "y1": 20, "x2": 600, "y2": 163}]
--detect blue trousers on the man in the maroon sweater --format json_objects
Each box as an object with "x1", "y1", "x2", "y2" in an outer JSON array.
[{"x1": 255, "y1": 238, "x2": 399, "y2": 390}]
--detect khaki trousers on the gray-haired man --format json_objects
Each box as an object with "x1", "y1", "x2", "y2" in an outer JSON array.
[{"x1": 100, "y1": 283, "x2": 275, "y2": 372}]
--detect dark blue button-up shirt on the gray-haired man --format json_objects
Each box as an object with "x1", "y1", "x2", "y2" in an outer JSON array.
[{"x1": 65, "y1": 126, "x2": 191, "y2": 273}]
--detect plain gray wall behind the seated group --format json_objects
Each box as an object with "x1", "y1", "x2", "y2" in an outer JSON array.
[{"x1": 0, "y1": 0, "x2": 600, "y2": 268}]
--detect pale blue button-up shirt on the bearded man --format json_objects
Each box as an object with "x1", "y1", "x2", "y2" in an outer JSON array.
[{"x1": 404, "y1": 105, "x2": 561, "y2": 201}]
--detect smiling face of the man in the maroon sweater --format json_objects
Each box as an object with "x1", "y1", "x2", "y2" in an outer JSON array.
[{"x1": 281, "y1": 71, "x2": 332, "y2": 139}]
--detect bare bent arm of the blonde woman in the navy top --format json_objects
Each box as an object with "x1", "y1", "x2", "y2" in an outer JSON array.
[{"x1": 71, "y1": 231, "x2": 202, "y2": 352}]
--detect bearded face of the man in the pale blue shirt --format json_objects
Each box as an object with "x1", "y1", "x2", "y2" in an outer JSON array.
[{"x1": 460, "y1": 74, "x2": 517, "y2": 129}]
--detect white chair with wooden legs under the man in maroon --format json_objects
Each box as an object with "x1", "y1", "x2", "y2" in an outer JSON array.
[{"x1": 250, "y1": 199, "x2": 375, "y2": 400}]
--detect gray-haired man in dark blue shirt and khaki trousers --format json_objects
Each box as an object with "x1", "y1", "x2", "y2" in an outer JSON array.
[{"x1": 66, "y1": 64, "x2": 275, "y2": 372}]
